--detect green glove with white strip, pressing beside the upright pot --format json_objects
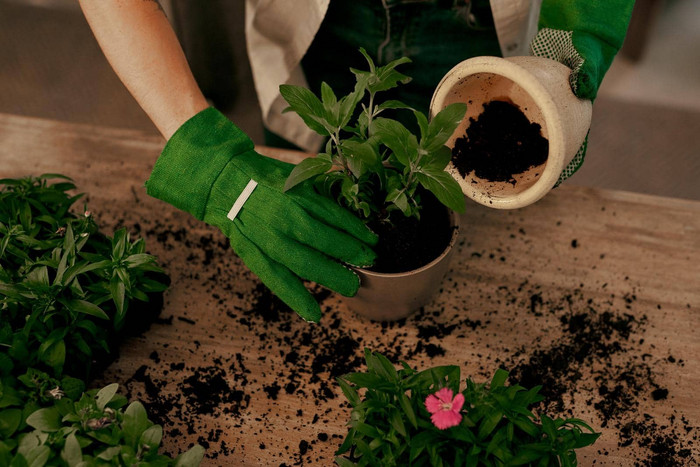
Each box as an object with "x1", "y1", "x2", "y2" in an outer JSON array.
[{"x1": 146, "y1": 108, "x2": 377, "y2": 322}]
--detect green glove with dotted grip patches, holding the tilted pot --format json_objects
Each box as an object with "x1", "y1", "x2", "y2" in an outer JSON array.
[{"x1": 530, "y1": 0, "x2": 634, "y2": 183}]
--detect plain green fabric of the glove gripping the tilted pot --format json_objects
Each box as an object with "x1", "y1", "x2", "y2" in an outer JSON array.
[{"x1": 538, "y1": 0, "x2": 634, "y2": 100}]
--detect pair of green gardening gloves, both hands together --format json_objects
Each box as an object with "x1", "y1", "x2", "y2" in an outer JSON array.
[{"x1": 146, "y1": 0, "x2": 633, "y2": 322}]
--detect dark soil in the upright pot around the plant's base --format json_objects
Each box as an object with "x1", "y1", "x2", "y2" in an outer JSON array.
[{"x1": 369, "y1": 191, "x2": 454, "y2": 273}]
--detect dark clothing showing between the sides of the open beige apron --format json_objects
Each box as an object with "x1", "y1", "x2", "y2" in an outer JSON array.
[{"x1": 302, "y1": 0, "x2": 501, "y2": 131}]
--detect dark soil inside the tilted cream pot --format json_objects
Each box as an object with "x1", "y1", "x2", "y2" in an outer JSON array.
[{"x1": 452, "y1": 101, "x2": 549, "y2": 185}]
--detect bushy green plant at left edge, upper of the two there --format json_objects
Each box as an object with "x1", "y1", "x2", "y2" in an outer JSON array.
[{"x1": 0, "y1": 174, "x2": 169, "y2": 375}]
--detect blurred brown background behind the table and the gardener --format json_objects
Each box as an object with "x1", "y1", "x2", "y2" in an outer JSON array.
[{"x1": 0, "y1": 0, "x2": 700, "y2": 200}]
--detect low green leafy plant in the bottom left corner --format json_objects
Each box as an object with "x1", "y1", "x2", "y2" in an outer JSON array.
[{"x1": 0, "y1": 370, "x2": 204, "y2": 467}]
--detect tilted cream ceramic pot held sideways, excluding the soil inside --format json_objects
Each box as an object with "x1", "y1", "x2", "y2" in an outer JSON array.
[{"x1": 430, "y1": 57, "x2": 592, "y2": 209}]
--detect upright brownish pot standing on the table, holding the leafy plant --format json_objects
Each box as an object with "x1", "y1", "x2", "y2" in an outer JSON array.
[{"x1": 345, "y1": 211, "x2": 459, "y2": 321}]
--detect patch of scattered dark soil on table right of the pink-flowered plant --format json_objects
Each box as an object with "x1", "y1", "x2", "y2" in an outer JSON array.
[{"x1": 494, "y1": 285, "x2": 692, "y2": 467}]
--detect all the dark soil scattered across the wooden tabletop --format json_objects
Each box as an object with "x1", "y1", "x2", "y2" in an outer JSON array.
[{"x1": 95, "y1": 203, "x2": 697, "y2": 467}]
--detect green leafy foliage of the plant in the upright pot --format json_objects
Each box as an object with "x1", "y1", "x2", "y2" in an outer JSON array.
[{"x1": 280, "y1": 49, "x2": 466, "y2": 221}]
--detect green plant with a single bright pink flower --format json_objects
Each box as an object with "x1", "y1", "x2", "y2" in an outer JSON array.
[{"x1": 336, "y1": 349, "x2": 600, "y2": 467}]
